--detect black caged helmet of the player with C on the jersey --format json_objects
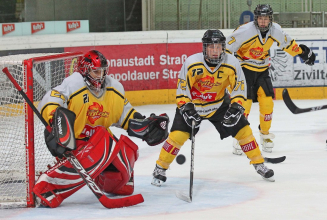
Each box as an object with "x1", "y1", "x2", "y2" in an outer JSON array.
[{"x1": 202, "y1": 29, "x2": 226, "y2": 64}]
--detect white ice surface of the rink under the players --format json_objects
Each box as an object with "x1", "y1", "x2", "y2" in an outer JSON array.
[{"x1": 0, "y1": 100, "x2": 327, "y2": 220}]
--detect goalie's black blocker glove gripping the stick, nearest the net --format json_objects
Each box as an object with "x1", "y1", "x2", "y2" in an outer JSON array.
[{"x1": 44, "y1": 107, "x2": 76, "y2": 158}]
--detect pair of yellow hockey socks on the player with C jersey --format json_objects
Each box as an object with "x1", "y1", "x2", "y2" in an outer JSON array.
[{"x1": 157, "y1": 125, "x2": 264, "y2": 169}]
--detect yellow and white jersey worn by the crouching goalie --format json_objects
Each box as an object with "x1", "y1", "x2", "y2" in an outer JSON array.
[{"x1": 38, "y1": 72, "x2": 136, "y2": 139}]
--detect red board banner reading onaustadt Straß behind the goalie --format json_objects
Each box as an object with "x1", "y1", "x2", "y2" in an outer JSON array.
[{"x1": 65, "y1": 43, "x2": 202, "y2": 91}]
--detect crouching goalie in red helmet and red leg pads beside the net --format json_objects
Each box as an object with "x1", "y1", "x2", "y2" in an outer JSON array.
[{"x1": 33, "y1": 50, "x2": 169, "y2": 208}]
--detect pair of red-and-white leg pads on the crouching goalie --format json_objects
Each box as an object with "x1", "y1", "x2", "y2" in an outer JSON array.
[{"x1": 33, "y1": 127, "x2": 138, "y2": 208}]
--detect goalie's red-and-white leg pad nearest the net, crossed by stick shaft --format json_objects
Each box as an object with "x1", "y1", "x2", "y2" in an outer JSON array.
[{"x1": 33, "y1": 127, "x2": 119, "y2": 208}]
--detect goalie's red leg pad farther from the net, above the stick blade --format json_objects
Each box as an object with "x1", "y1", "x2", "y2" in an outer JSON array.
[{"x1": 96, "y1": 135, "x2": 138, "y2": 195}]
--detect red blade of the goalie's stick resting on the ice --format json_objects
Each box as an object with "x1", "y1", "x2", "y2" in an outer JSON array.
[{"x1": 99, "y1": 194, "x2": 144, "y2": 209}]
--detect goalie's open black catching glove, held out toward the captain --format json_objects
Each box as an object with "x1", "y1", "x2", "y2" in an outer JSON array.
[{"x1": 127, "y1": 113, "x2": 169, "y2": 146}]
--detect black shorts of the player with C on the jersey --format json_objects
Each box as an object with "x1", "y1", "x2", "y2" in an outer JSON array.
[{"x1": 170, "y1": 94, "x2": 249, "y2": 139}]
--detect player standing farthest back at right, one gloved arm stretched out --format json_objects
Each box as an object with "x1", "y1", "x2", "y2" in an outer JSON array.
[{"x1": 226, "y1": 4, "x2": 315, "y2": 155}]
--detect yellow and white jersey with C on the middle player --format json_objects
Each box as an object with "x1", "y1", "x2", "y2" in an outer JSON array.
[{"x1": 176, "y1": 53, "x2": 247, "y2": 118}]
